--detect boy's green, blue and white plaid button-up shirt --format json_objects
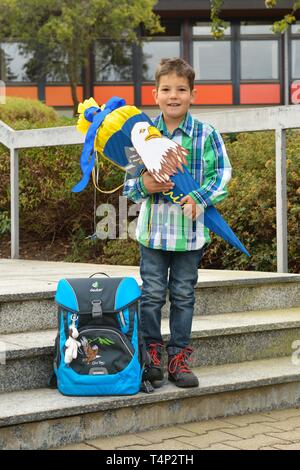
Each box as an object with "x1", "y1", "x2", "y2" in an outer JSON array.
[{"x1": 123, "y1": 113, "x2": 231, "y2": 251}]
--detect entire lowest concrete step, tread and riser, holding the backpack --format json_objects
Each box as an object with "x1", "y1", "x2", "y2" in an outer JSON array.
[{"x1": 0, "y1": 356, "x2": 300, "y2": 449}]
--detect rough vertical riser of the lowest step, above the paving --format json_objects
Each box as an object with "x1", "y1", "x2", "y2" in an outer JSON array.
[{"x1": 0, "y1": 382, "x2": 300, "y2": 450}]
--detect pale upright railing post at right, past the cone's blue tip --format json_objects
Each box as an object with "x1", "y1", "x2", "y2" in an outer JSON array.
[{"x1": 275, "y1": 128, "x2": 288, "y2": 273}]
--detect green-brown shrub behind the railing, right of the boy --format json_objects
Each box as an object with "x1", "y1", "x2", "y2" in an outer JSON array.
[{"x1": 203, "y1": 130, "x2": 300, "y2": 273}]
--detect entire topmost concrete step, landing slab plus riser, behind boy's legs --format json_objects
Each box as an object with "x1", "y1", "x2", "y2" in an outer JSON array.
[{"x1": 0, "y1": 260, "x2": 300, "y2": 334}]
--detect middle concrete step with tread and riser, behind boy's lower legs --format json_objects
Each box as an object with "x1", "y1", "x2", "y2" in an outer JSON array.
[{"x1": 0, "y1": 307, "x2": 300, "y2": 393}]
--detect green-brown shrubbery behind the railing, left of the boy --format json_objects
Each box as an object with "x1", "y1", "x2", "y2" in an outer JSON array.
[{"x1": 0, "y1": 98, "x2": 124, "y2": 253}]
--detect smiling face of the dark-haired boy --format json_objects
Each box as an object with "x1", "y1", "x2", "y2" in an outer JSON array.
[{"x1": 153, "y1": 73, "x2": 196, "y2": 123}]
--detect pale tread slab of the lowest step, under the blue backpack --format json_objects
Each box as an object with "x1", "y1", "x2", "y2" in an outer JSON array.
[{"x1": 0, "y1": 357, "x2": 300, "y2": 427}]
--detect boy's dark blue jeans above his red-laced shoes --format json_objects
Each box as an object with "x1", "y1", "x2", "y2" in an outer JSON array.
[{"x1": 140, "y1": 244, "x2": 205, "y2": 355}]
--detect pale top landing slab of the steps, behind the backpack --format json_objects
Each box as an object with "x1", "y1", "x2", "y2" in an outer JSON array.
[{"x1": 0, "y1": 259, "x2": 300, "y2": 303}]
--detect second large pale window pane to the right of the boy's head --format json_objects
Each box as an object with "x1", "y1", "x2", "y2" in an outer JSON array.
[{"x1": 241, "y1": 40, "x2": 279, "y2": 80}]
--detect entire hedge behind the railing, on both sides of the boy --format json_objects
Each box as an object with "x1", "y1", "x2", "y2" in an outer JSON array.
[{"x1": 0, "y1": 100, "x2": 300, "y2": 272}]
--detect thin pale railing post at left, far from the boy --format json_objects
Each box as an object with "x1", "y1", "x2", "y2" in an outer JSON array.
[{"x1": 10, "y1": 149, "x2": 19, "y2": 259}]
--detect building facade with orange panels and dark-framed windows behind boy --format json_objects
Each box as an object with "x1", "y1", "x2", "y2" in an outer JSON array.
[{"x1": 0, "y1": 0, "x2": 300, "y2": 108}]
